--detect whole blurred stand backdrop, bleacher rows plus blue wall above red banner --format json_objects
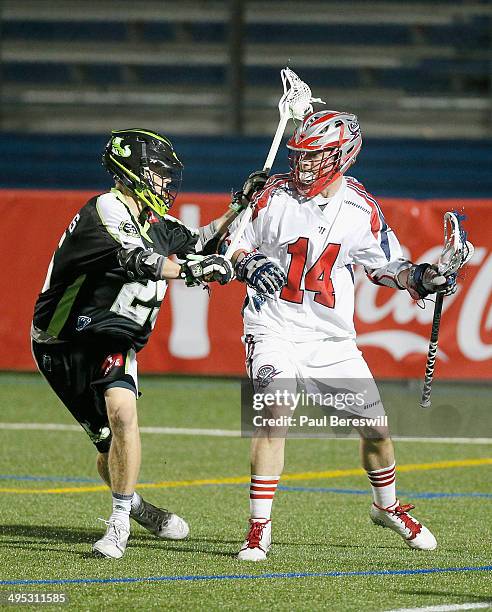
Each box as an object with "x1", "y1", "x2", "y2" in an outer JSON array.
[{"x1": 0, "y1": 0, "x2": 492, "y2": 197}]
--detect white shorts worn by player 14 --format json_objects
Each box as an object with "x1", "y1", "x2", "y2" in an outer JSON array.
[{"x1": 243, "y1": 334, "x2": 385, "y2": 418}]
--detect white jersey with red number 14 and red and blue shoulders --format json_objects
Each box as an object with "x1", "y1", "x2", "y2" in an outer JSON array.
[{"x1": 231, "y1": 175, "x2": 408, "y2": 342}]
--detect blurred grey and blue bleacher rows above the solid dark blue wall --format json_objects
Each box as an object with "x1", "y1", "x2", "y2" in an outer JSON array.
[{"x1": 1, "y1": 0, "x2": 492, "y2": 138}]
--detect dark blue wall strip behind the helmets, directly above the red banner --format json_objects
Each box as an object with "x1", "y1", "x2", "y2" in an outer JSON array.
[{"x1": 0, "y1": 133, "x2": 492, "y2": 198}]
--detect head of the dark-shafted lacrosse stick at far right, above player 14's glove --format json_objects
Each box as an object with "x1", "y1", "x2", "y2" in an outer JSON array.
[{"x1": 437, "y1": 211, "x2": 475, "y2": 276}]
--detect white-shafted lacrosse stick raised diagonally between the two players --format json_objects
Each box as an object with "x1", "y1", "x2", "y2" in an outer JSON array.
[{"x1": 225, "y1": 68, "x2": 325, "y2": 258}]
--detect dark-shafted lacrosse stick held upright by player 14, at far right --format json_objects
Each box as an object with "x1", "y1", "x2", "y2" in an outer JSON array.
[{"x1": 420, "y1": 212, "x2": 474, "y2": 408}]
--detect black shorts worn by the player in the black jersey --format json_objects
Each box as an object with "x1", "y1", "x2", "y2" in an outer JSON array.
[{"x1": 32, "y1": 341, "x2": 138, "y2": 453}]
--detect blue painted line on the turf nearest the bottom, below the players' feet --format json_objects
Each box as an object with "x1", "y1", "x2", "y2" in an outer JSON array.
[{"x1": 0, "y1": 565, "x2": 492, "y2": 586}]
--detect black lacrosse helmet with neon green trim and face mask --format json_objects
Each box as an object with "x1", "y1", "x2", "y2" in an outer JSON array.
[{"x1": 102, "y1": 129, "x2": 183, "y2": 215}]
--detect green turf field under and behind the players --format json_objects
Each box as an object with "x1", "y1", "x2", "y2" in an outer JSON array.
[{"x1": 0, "y1": 374, "x2": 492, "y2": 611}]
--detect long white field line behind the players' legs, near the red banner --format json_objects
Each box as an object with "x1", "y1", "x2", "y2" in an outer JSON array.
[{"x1": 0, "y1": 423, "x2": 492, "y2": 444}]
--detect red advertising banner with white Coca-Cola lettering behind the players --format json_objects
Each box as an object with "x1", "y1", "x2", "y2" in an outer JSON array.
[{"x1": 0, "y1": 190, "x2": 492, "y2": 379}]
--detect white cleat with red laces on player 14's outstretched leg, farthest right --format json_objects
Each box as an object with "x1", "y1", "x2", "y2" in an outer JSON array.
[{"x1": 370, "y1": 500, "x2": 437, "y2": 550}]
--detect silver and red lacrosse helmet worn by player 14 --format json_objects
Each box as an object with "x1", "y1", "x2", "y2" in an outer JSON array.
[{"x1": 287, "y1": 110, "x2": 362, "y2": 198}]
